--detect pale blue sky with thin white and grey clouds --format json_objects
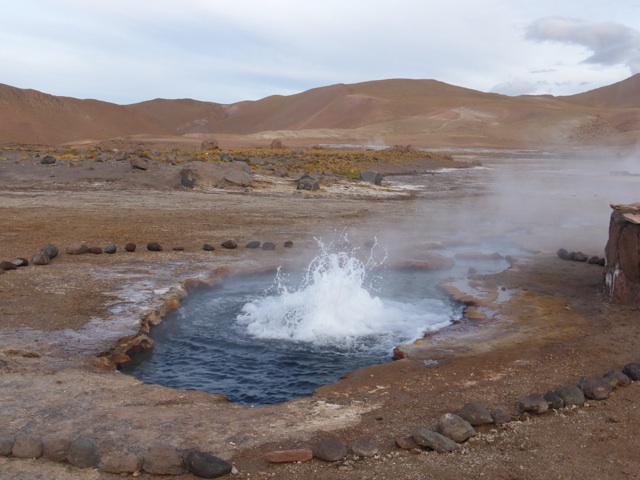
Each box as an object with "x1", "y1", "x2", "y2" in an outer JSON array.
[{"x1": 0, "y1": 0, "x2": 640, "y2": 104}]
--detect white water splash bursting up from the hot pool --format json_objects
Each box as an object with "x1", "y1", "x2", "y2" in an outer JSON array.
[{"x1": 237, "y1": 239, "x2": 455, "y2": 350}]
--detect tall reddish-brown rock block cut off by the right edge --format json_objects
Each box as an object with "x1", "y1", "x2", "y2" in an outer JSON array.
[{"x1": 604, "y1": 203, "x2": 640, "y2": 307}]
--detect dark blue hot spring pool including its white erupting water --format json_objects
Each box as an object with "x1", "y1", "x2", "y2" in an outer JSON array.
[{"x1": 123, "y1": 244, "x2": 503, "y2": 405}]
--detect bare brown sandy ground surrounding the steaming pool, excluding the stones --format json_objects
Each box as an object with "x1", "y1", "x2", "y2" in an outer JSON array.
[{"x1": 0, "y1": 144, "x2": 640, "y2": 479}]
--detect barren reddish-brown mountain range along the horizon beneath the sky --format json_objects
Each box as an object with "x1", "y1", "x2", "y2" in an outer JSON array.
[{"x1": 0, "y1": 75, "x2": 640, "y2": 147}]
